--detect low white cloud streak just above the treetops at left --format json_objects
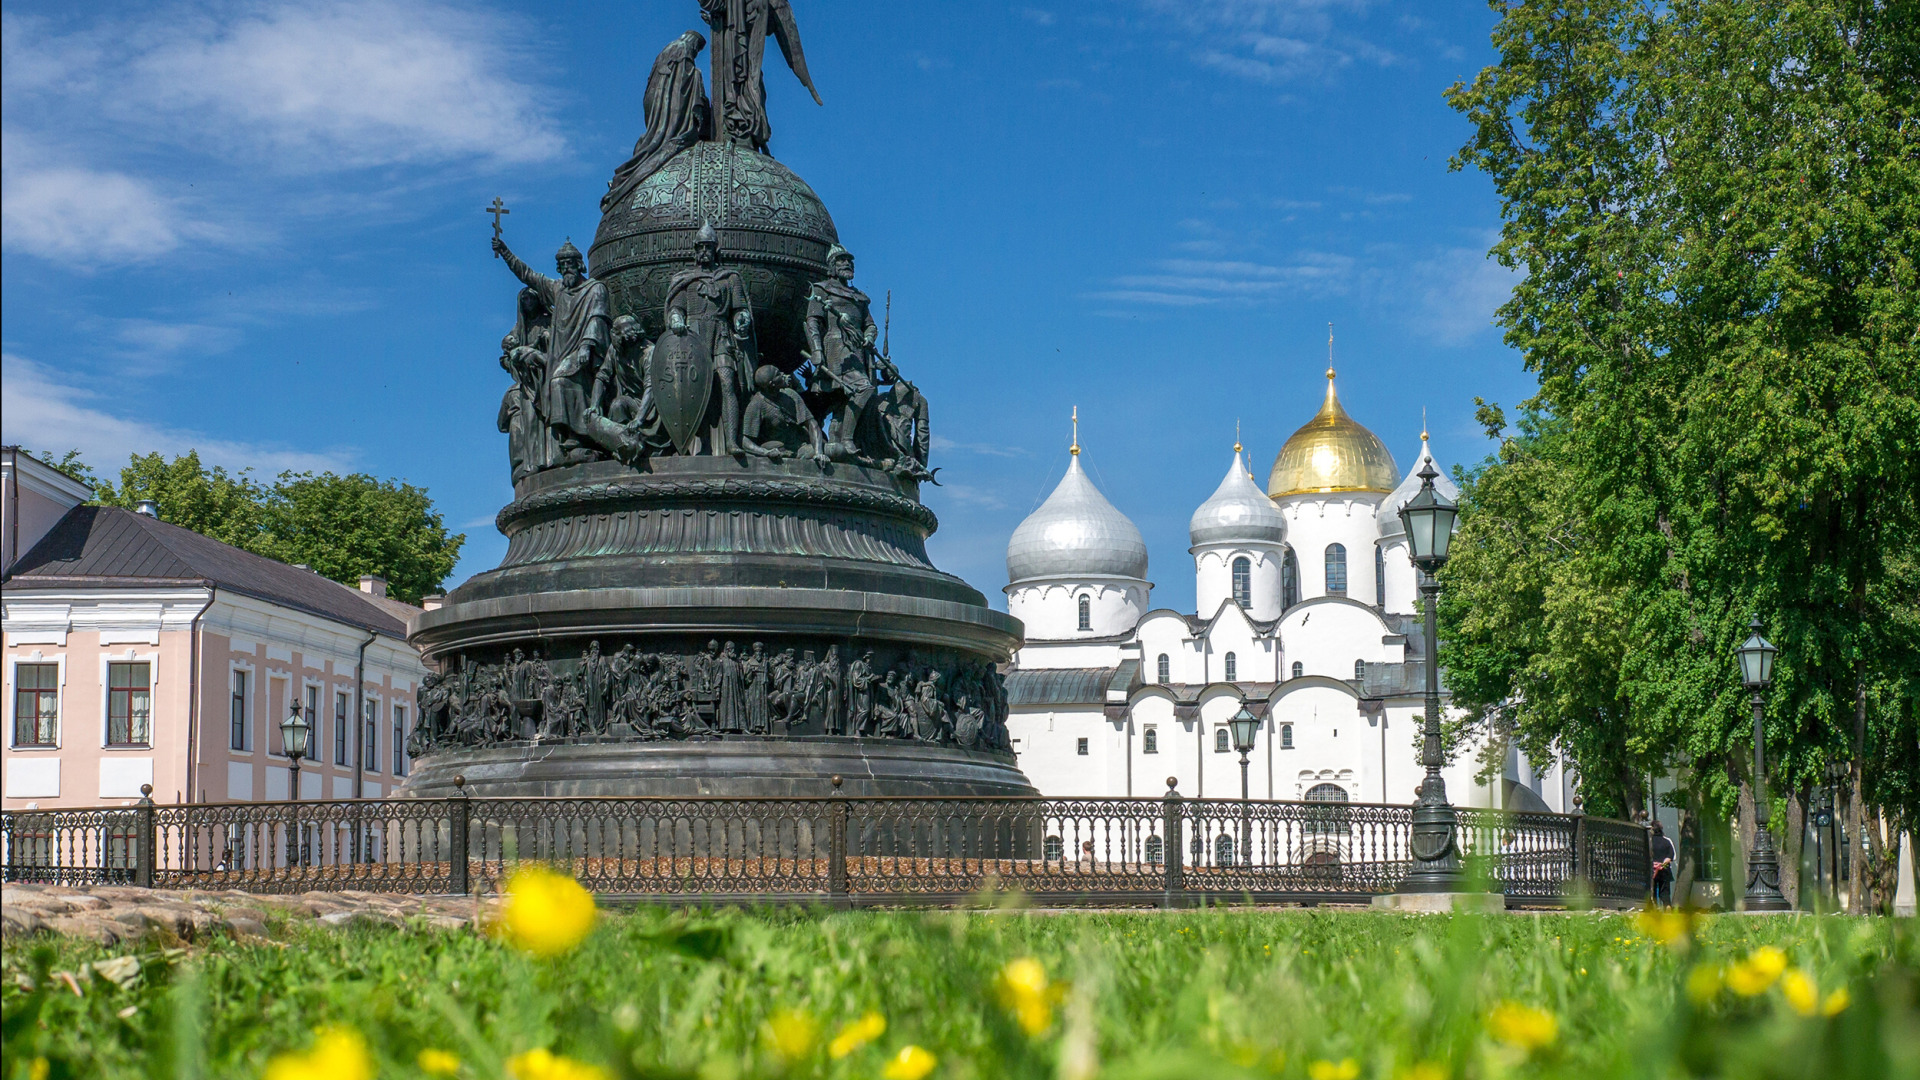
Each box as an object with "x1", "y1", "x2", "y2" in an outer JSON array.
[{"x1": 0, "y1": 354, "x2": 353, "y2": 477}]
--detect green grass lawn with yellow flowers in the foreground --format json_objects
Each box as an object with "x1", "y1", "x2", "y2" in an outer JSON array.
[{"x1": 4, "y1": 911, "x2": 1920, "y2": 1080}]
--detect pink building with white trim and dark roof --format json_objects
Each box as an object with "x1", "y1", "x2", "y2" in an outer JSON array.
[{"x1": 0, "y1": 448, "x2": 426, "y2": 811}]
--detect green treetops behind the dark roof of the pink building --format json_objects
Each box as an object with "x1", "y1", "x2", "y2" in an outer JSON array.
[{"x1": 42, "y1": 443, "x2": 467, "y2": 603}]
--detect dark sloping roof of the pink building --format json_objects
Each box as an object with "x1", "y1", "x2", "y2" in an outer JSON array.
[{"x1": 6, "y1": 505, "x2": 415, "y2": 638}]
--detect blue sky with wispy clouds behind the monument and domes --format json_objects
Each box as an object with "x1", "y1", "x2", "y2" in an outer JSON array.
[{"x1": 0, "y1": 0, "x2": 1532, "y2": 609}]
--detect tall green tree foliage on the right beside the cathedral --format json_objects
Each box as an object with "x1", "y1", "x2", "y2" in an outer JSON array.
[{"x1": 1442, "y1": 0, "x2": 1920, "y2": 907}]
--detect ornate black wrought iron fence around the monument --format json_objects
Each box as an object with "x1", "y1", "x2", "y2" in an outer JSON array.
[{"x1": 0, "y1": 776, "x2": 1651, "y2": 907}]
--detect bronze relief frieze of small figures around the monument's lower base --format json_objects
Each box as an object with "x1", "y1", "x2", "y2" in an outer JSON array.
[{"x1": 407, "y1": 640, "x2": 1010, "y2": 757}]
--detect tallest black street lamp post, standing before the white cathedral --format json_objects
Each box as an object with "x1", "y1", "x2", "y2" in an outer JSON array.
[{"x1": 1400, "y1": 461, "x2": 1467, "y2": 892}]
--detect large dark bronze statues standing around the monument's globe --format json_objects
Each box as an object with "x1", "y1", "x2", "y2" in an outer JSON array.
[{"x1": 493, "y1": 223, "x2": 933, "y2": 480}]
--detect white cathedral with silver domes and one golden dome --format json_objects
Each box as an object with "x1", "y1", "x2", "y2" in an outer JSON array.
[{"x1": 1006, "y1": 369, "x2": 1572, "y2": 813}]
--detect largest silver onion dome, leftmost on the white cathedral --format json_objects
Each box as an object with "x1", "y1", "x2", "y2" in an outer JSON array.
[{"x1": 1006, "y1": 454, "x2": 1146, "y2": 582}]
